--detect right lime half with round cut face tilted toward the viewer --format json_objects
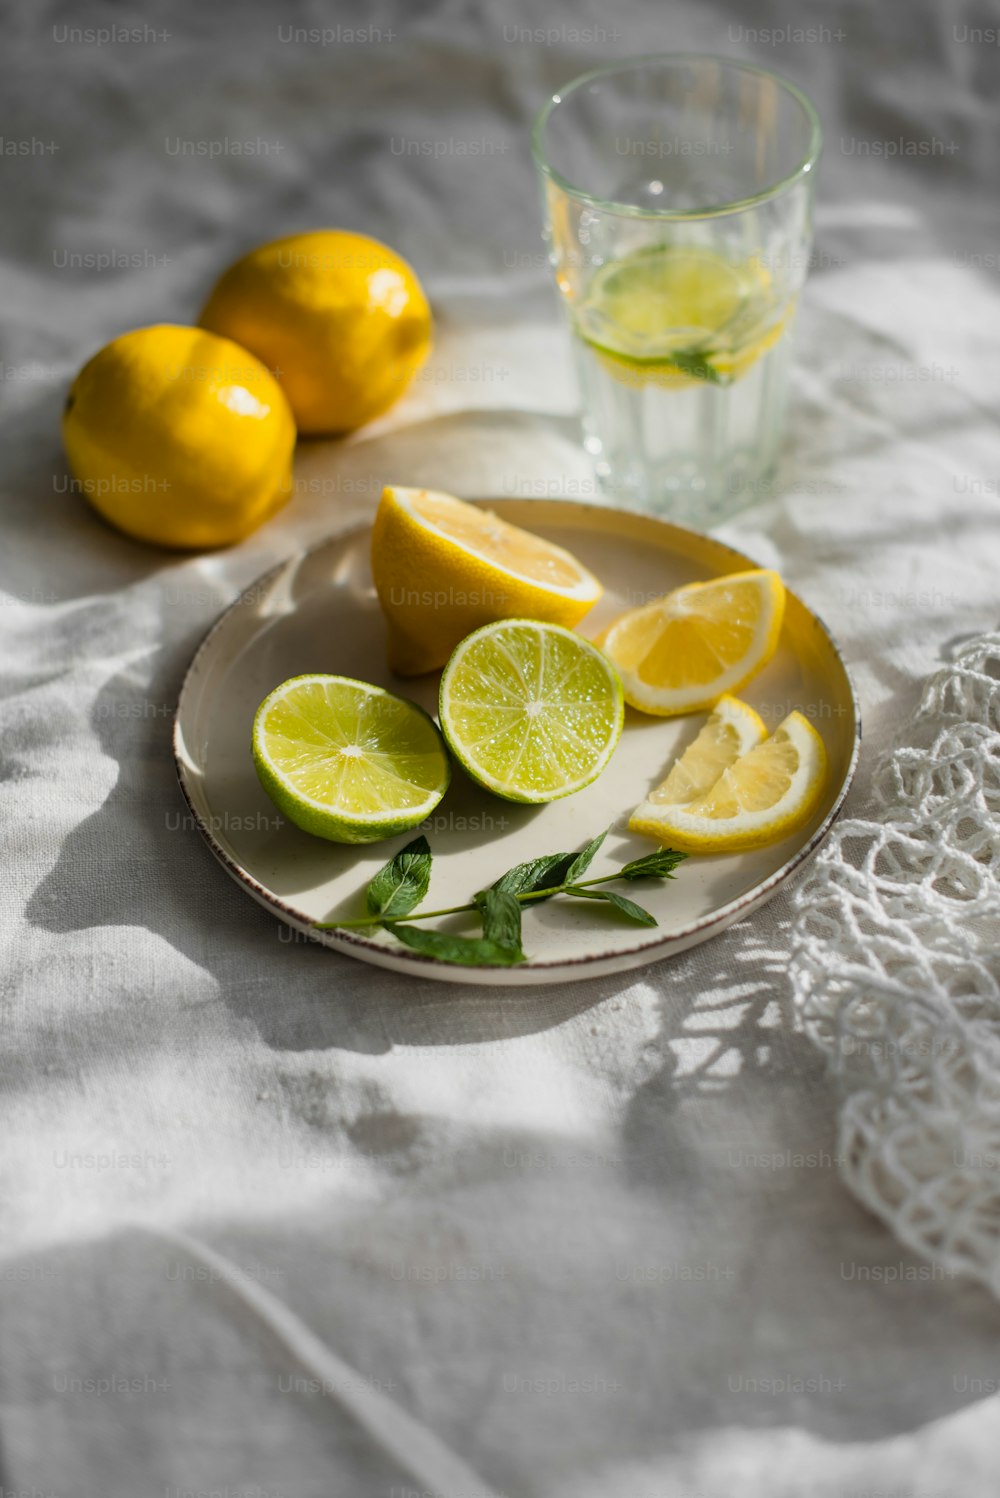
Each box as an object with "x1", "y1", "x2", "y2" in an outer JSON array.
[{"x1": 440, "y1": 619, "x2": 624, "y2": 801}]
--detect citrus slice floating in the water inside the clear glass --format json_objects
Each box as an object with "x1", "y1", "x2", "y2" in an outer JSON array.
[{"x1": 576, "y1": 244, "x2": 784, "y2": 386}]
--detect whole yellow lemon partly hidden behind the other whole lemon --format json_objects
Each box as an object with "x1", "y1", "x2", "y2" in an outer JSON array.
[{"x1": 199, "y1": 229, "x2": 431, "y2": 434}]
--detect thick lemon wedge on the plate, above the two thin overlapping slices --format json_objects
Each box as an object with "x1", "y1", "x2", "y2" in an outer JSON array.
[{"x1": 602, "y1": 568, "x2": 784, "y2": 718}]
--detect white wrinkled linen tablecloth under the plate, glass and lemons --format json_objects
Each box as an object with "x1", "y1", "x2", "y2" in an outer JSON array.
[{"x1": 0, "y1": 0, "x2": 1000, "y2": 1498}]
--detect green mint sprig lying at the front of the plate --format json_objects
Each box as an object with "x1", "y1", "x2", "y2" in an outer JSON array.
[{"x1": 316, "y1": 831, "x2": 687, "y2": 968}]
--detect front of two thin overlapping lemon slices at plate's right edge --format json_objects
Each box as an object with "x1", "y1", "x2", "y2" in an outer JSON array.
[{"x1": 629, "y1": 713, "x2": 826, "y2": 852}]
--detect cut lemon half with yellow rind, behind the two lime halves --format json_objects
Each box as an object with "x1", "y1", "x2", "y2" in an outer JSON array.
[{"x1": 371, "y1": 485, "x2": 602, "y2": 676}]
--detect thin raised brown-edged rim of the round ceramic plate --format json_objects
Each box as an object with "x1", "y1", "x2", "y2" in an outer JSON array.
[{"x1": 171, "y1": 494, "x2": 861, "y2": 987}]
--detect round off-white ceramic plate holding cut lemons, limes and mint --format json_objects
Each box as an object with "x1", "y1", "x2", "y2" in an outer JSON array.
[{"x1": 174, "y1": 499, "x2": 861, "y2": 986}]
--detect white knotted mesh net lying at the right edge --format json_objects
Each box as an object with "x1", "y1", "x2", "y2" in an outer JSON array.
[{"x1": 790, "y1": 634, "x2": 1000, "y2": 1296}]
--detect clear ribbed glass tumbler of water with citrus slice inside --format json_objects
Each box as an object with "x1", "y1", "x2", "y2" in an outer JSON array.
[{"x1": 531, "y1": 52, "x2": 822, "y2": 527}]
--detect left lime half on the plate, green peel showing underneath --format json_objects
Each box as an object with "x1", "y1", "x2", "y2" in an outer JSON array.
[{"x1": 253, "y1": 676, "x2": 451, "y2": 843}]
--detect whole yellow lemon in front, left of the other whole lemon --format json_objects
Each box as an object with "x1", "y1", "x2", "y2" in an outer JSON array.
[{"x1": 63, "y1": 324, "x2": 295, "y2": 548}]
